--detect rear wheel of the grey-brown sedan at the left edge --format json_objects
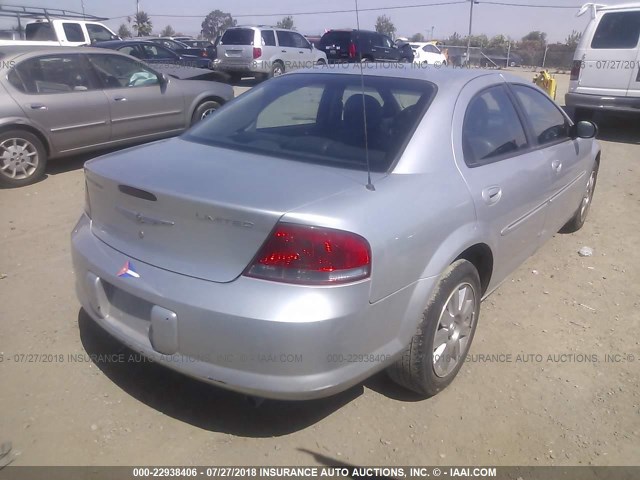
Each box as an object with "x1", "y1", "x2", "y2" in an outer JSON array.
[{"x1": 0, "y1": 129, "x2": 47, "y2": 188}]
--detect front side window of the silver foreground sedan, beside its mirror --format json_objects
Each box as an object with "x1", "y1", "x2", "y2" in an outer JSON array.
[{"x1": 512, "y1": 85, "x2": 569, "y2": 145}]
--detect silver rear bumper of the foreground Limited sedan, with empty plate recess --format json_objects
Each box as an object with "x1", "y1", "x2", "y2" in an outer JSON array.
[{"x1": 71, "y1": 215, "x2": 437, "y2": 400}]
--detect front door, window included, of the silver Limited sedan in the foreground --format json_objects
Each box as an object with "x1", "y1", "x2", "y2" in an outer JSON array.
[{"x1": 510, "y1": 84, "x2": 592, "y2": 241}]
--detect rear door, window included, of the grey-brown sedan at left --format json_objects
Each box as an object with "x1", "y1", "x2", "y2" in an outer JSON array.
[{"x1": 8, "y1": 54, "x2": 110, "y2": 152}]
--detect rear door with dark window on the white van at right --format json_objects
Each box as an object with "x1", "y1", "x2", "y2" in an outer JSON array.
[{"x1": 578, "y1": 10, "x2": 640, "y2": 97}]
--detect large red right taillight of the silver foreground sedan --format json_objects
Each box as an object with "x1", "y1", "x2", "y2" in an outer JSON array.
[{"x1": 245, "y1": 223, "x2": 371, "y2": 285}]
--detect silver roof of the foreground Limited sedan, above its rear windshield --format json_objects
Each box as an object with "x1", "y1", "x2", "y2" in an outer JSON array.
[{"x1": 287, "y1": 63, "x2": 528, "y2": 90}]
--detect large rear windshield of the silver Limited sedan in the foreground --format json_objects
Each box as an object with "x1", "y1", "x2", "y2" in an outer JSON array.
[{"x1": 184, "y1": 73, "x2": 436, "y2": 172}]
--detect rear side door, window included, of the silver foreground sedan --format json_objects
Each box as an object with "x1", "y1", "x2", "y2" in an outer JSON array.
[{"x1": 453, "y1": 77, "x2": 550, "y2": 284}]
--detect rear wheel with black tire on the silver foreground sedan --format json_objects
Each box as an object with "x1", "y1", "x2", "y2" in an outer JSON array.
[{"x1": 387, "y1": 260, "x2": 482, "y2": 397}]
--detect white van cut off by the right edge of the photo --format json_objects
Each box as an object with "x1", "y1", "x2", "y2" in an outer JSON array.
[{"x1": 565, "y1": 3, "x2": 640, "y2": 120}]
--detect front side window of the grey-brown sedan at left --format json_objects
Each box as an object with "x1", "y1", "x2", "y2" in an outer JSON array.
[{"x1": 89, "y1": 55, "x2": 159, "y2": 89}]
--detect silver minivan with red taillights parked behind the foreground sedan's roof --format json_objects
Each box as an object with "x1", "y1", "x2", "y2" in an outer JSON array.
[{"x1": 213, "y1": 26, "x2": 327, "y2": 80}]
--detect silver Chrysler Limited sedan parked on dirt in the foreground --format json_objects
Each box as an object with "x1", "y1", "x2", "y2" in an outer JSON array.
[{"x1": 72, "y1": 67, "x2": 600, "y2": 399}]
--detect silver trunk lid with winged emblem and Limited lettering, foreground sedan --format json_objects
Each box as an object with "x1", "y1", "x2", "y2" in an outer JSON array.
[{"x1": 86, "y1": 139, "x2": 364, "y2": 282}]
